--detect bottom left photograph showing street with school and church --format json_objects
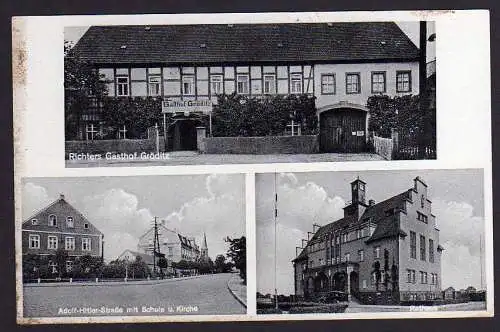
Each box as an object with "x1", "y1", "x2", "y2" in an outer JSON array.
[{"x1": 16, "y1": 174, "x2": 247, "y2": 318}]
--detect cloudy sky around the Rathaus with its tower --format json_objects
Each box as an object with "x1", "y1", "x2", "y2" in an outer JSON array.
[{"x1": 255, "y1": 169, "x2": 485, "y2": 294}]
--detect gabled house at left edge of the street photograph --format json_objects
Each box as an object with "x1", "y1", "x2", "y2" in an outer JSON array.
[{"x1": 22, "y1": 194, "x2": 104, "y2": 273}]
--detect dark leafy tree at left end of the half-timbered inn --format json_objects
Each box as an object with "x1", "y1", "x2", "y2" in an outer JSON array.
[{"x1": 64, "y1": 41, "x2": 107, "y2": 140}]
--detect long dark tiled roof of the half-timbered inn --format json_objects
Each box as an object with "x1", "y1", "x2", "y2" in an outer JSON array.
[{"x1": 73, "y1": 22, "x2": 420, "y2": 65}]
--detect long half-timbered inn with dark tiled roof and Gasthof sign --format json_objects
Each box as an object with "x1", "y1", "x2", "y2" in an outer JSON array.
[{"x1": 73, "y1": 22, "x2": 425, "y2": 152}]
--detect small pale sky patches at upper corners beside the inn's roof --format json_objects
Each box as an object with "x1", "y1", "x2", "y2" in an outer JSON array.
[{"x1": 64, "y1": 22, "x2": 436, "y2": 61}]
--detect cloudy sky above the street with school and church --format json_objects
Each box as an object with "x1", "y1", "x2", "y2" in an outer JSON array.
[{"x1": 22, "y1": 174, "x2": 245, "y2": 261}]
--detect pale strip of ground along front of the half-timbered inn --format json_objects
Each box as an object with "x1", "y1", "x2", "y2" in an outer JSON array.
[{"x1": 66, "y1": 151, "x2": 383, "y2": 167}]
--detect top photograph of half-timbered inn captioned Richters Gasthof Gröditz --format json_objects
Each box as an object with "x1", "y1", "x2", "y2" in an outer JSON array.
[{"x1": 64, "y1": 21, "x2": 437, "y2": 167}]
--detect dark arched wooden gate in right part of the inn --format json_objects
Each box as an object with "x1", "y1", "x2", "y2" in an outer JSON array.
[{"x1": 319, "y1": 107, "x2": 367, "y2": 152}]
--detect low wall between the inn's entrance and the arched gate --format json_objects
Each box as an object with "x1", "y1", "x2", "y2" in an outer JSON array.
[{"x1": 201, "y1": 135, "x2": 319, "y2": 154}]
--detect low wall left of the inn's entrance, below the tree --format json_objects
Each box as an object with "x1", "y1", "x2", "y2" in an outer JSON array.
[{"x1": 65, "y1": 137, "x2": 158, "y2": 159}]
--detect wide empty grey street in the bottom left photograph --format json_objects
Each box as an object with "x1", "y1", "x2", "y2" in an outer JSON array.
[{"x1": 24, "y1": 274, "x2": 246, "y2": 317}]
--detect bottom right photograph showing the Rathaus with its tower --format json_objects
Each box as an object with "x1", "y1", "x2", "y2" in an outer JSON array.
[{"x1": 255, "y1": 169, "x2": 493, "y2": 314}]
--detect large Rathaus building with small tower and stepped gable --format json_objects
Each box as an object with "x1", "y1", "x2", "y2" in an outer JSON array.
[{"x1": 293, "y1": 177, "x2": 443, "y2": 304}]
